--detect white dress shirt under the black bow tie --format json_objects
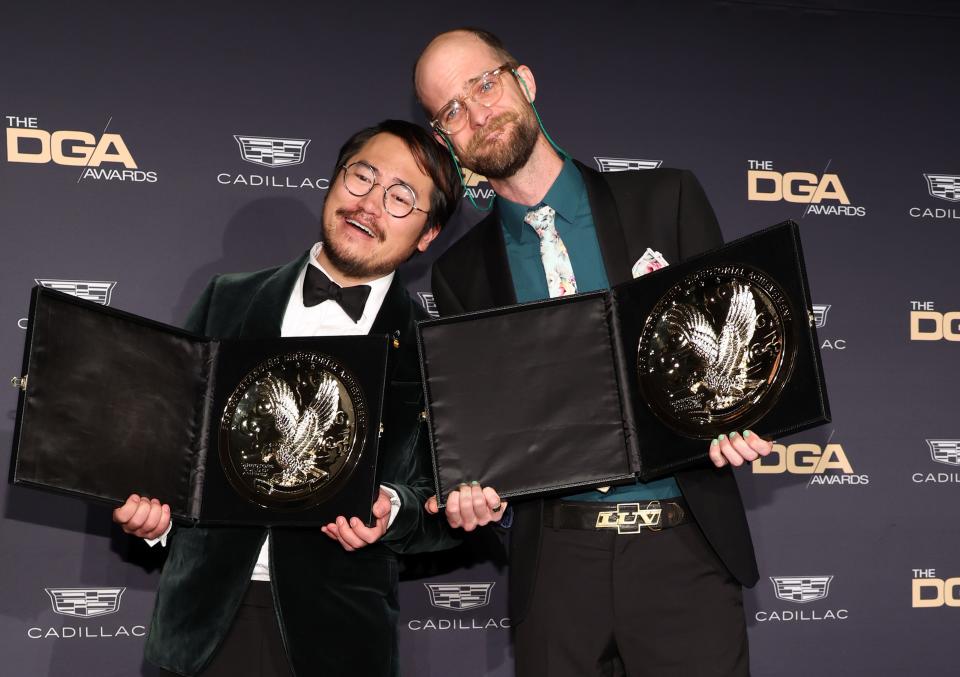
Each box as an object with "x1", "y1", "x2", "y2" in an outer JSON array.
[{"x1": 147, "y1": 242, "x2": 400, "y2": 581}]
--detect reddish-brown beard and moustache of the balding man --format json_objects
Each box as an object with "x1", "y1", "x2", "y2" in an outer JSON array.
[{"x1": 460, "y1": 107, "x2": 540, "y2": 179}]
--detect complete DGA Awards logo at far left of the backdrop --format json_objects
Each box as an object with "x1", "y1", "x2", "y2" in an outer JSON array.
[{"x1": 5, "y1": 115, "x2": 157, "y2": 183}]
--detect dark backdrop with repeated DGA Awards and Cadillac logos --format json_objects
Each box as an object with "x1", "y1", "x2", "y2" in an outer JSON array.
[{"x1": 0, "y1": 1, "x2": 960, "y2": 677}]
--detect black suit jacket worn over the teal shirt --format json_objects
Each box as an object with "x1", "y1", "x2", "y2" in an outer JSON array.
[{"x1": 432, "y1": 163, "x2": 758, "y2": 622}]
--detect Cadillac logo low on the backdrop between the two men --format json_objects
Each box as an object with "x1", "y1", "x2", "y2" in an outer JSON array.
[{"x1": 407, "y1": 582, "x2": 510, "y2": 632}]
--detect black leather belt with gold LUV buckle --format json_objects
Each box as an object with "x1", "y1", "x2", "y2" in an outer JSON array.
[{"x1": 543, "y1": 496, "x2": 691, "y2": 534}]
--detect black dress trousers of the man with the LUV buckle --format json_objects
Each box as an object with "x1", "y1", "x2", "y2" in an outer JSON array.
[{"x1": 514, "y1": 523, "x2": 750, "y2": 677}]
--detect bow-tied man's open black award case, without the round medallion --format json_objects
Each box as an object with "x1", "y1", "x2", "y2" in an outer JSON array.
[{"x1": 10, "y1": 287, "x2": 389, "y2": 525}]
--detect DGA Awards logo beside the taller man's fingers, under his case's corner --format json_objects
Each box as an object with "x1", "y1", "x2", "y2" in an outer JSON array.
[{"x1": 750, "y1": 442, "x2": 870, "y2": 486}]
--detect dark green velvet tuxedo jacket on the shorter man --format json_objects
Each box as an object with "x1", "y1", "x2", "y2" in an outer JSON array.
[{"x1": 146, "y1": 254, "x2": 456, "y2": 675}]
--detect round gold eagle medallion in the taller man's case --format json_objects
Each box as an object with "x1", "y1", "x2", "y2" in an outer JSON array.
[{"x1": 637, "y1": 265, "x2": 797, "y2": 438}]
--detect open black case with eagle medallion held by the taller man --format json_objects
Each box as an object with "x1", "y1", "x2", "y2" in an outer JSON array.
[{"x1": 418, "y1": 222, "x2": 830, "y2": 500}]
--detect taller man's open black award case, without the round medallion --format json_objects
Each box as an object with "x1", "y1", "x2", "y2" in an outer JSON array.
[{"x1": 418, "y1": 222, "x2": 830, "y2": 501}]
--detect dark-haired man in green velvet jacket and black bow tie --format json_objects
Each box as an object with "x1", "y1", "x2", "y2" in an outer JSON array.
[{"x1": 114, "y1": 120, "x2": 459, "y2": 677}]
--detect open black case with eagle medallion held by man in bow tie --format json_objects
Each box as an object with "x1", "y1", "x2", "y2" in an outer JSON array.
[{"x1": 10, "y1": 287, "x2": 390, "y2": 525}]
